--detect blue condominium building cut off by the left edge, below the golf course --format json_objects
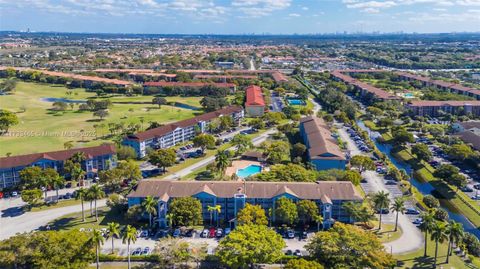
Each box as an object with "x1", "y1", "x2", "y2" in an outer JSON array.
[{"x1": 0, "y1": 144, "x2": 117, "y2": 188}]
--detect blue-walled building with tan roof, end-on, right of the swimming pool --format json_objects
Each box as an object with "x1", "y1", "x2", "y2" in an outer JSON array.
[{"x1": 300, "y1": 116, "x2": 346, "y2": 170}]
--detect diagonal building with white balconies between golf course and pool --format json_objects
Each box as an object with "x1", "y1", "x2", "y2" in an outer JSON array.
[{"x1": 122, "y1": 106, "x2": 244, "y2": 158}]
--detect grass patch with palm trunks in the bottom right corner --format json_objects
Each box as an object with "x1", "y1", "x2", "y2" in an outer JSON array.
[{"x1": 394, "y1": 234, "x2": 478, "y2": 269}]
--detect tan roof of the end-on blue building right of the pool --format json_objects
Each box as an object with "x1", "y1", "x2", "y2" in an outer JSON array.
[{"x1": 300, "y1": 116, "x2": 345, "y2": 160}]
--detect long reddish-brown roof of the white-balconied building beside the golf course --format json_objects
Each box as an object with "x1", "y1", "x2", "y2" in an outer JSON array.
[{"x1": 128, "y1": 106, "x2": 243, "y2": 141}]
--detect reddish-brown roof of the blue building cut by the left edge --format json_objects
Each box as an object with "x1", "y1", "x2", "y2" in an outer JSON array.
[{"x1": 0, "y1": 144, "x2": 116, "y2": 168}]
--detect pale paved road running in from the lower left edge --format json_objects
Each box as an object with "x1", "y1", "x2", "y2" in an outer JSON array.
[{"x1": 0, "y1": 199, "x2": 106, "y2": 240}]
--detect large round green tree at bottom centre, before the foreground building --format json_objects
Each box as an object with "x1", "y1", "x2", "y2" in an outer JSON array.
[{"x1": 216, "y1": 225, "x2": 285, "y2": 269}]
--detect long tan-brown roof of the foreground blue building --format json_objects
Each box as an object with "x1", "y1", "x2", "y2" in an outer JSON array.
[{"x1": 128, "y1": 180, "x2": 362, "y2": 200}]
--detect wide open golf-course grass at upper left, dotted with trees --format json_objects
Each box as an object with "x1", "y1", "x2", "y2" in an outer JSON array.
[{"x1": 0, "y1": 82, "x2": 201, "y2": 156}]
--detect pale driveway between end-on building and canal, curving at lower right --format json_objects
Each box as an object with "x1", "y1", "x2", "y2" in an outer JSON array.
[{"x1": 338, "y1": 128, "x2": 424, "y2": 254}]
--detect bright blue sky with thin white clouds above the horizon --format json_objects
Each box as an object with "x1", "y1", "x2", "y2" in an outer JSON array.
[{"x1": 0, "y1": 0, "x2": 480, "y2": 34}]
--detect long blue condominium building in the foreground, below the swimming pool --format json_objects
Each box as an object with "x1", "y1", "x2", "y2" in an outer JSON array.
[{"x1": 128, "y1": 180, "x2": 362, "y2": 228}]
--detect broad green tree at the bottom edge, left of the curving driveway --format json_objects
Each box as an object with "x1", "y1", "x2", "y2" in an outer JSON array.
[{"x1": 305, "y1": 222, "x2": 395, "y2": 268}]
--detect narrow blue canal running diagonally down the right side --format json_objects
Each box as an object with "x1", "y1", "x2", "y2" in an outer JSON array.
[{"x1": 357, "y1": 120, "x2": 480, "y2": 239}]
